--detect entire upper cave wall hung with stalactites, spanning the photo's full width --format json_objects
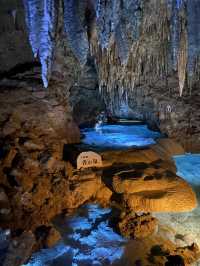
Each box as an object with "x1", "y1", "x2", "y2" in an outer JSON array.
[{"x1": 0, "y1": 0, "x2": 200, "y2": 149}]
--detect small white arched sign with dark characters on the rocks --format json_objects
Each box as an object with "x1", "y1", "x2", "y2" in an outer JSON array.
[{"x1": 77, "y1": 151, "x2": 103, "y2": 169}]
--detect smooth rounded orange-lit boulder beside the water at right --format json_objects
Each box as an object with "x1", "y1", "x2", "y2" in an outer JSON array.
[{"x1": 113, "y1": 165, "x2": 197, "y2": 212}]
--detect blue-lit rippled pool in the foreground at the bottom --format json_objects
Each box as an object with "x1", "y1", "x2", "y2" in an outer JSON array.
[{"x1": 23, "y1": 204, "x2": 126, "y2": 266}]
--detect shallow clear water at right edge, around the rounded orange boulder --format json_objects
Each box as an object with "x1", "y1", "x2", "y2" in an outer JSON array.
[{"x1": 154, "y1": 154, "x2": 200, "y2": 246}]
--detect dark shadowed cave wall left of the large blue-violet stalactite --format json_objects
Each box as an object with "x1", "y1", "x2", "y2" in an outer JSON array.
[{"x1": 0, "y1": 0, "x2": 34, "y2": 73}]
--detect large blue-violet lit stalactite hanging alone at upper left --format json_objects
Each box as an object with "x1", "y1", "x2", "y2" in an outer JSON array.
[{"x1": 24, "y1": 0, "x2": 57, "y2": 88}]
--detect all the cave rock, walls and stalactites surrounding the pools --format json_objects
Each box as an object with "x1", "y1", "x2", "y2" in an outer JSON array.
[{"x1": 0, "y1": 0, "x2": 200, "y2": 266}]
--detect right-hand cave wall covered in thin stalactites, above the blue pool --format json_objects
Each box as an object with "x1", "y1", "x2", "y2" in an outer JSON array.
[{"x1": 91, "y1": 0, "x2": 200, "y2": 151}]
